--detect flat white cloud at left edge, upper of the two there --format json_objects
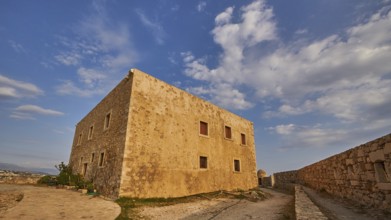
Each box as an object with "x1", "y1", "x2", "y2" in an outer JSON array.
[{"x1": 0, "y1": 74, "x2": 43, "y2": 98}]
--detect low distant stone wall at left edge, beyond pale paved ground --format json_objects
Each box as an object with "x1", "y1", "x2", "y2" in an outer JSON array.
[{"x1": 0, "y1": 170, "x2": 44, "y2": 184}]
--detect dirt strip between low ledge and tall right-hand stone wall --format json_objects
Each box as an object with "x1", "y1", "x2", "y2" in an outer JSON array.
[{"x1": 303, "y1": 187, "x2": 391, "y2": 220}]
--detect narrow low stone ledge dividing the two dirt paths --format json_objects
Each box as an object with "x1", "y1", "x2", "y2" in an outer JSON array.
[{"x1": 294, "y1": 185, "x2": 328, "y2": 220}]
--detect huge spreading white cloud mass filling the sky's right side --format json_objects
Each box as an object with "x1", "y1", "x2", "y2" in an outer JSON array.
[{"x1": 182, "y1": 0, "x2": 391, "y2": 147}]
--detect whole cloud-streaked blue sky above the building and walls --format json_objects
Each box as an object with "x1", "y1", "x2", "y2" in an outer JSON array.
[{"x1": 0, "y1": 0, "x2": 391, "y2": 173}]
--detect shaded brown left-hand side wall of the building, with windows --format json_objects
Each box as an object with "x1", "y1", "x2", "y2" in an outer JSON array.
[{"x1": 69, "y1": 76, "x2": 132, "y2": 198}]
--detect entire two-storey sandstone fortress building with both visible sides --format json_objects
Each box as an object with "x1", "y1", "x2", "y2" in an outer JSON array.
[{"x1": 69, "y1": 69, "x2": 257, "y2": 198}]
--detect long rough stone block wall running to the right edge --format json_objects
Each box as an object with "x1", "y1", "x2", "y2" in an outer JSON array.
[{"x1": 298, "y1": 134, "x2": 391, "y2": 211}]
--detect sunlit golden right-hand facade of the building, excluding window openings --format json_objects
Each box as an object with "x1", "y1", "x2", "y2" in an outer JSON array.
[{"x1": 120, "y1": 70, "x2": 257, "y2": 197}]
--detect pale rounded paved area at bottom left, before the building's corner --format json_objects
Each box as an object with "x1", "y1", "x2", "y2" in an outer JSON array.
[{"x1": 0, "y1": 184, "x2": 121, "y2": 220}]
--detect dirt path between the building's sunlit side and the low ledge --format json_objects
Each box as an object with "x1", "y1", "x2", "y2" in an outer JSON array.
[{"x1": 138, "y1": 189, "x2": 293, "y2": 220}]
